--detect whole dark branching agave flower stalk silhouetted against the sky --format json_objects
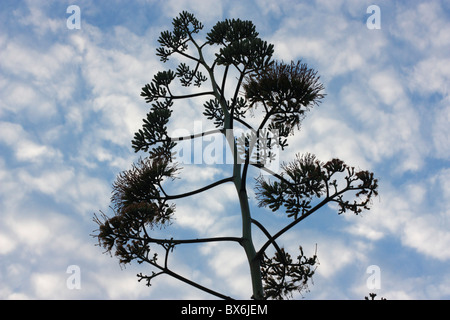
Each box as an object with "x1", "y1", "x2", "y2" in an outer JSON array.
[{"x1": 95, "y1": 12, "x2": 378, "y2": 299}]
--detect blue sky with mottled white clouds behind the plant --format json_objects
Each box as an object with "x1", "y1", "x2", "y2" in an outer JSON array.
[{"x1": 0, "y1": 0, "x2": 450, "y2": 300}]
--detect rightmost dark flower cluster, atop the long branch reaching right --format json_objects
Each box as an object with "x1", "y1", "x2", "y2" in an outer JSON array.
[{"x1": 256, "y1": 154, "x2": 378, "y2": 219}]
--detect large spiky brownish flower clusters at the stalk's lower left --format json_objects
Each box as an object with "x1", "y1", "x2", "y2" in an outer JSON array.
[{"x1": 95, "y1": 158, "x2": 177, "y2": 263}]
